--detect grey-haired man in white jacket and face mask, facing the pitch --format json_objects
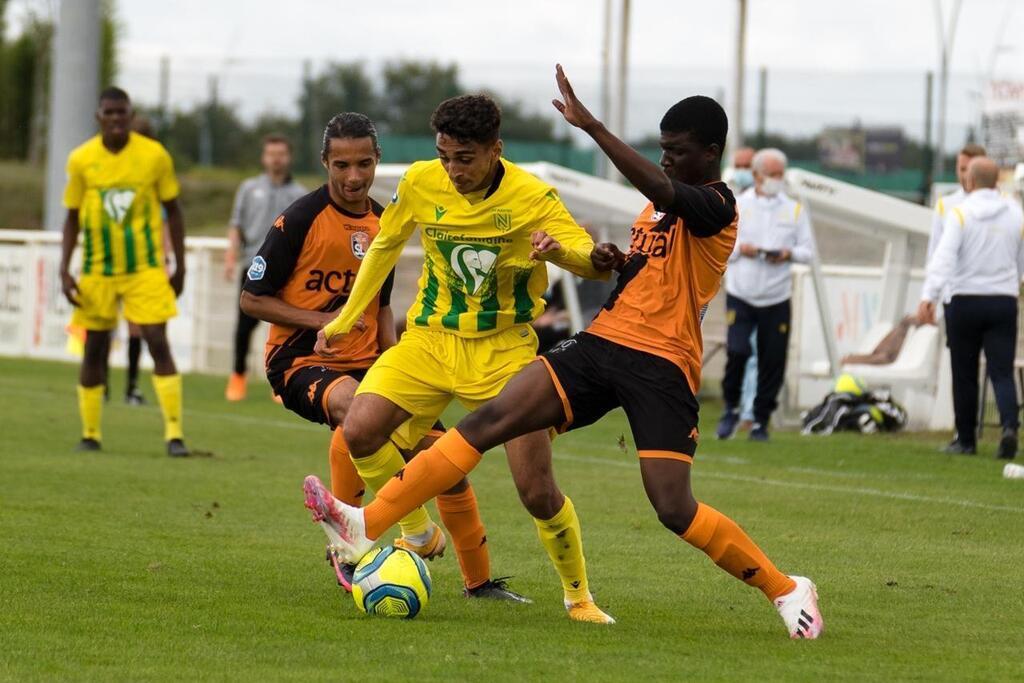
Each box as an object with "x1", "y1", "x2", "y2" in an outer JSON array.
[{"x1": 717, "y1": 148, "x2": 815, "y2": 441}]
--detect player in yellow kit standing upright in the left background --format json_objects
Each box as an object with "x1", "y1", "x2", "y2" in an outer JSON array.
[{"x1": 60, "y1": 88, "x2": 188, "y2": 457}]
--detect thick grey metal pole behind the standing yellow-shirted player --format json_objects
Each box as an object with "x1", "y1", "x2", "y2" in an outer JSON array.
[{"x1": 43, "y1": 0, "x2": 99, "y2": 230}]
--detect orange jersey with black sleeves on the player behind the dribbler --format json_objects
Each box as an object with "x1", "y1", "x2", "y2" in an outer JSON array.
[{"x1": 243, "y1": 185, "x2": 394, "y2": 383}]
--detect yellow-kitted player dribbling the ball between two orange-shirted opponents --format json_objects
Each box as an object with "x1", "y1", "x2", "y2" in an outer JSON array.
[{"x1": 304, "y1": 95, "x2": 613, "y2": 624}]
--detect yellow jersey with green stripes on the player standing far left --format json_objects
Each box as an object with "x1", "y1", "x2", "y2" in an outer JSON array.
[{"x1": 63, "y1": 133, "x2": 179, "y2": 275}]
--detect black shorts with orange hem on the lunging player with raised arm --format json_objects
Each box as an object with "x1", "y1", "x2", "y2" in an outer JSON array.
[{"x1": 541, "y1": 332, "x2": 699, "y2": 462}]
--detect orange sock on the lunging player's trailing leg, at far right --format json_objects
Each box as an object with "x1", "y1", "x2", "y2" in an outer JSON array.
[{"x1": 680, "y1": 503, "x2": 797, "y2": 600}]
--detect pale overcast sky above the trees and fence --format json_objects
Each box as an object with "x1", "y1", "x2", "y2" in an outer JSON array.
[{"x1": 9, "y1": 0, "x2": 1024, "y2": 145}]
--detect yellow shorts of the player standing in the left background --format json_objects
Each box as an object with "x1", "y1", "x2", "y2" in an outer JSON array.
[{"x1": 71, "y1": 268, "x2": 178, "y2": 332}]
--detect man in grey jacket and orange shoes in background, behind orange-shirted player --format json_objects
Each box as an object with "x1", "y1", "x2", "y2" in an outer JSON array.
[{"x1": 224, "y1": 135, "x2": 306, "y2": 400}]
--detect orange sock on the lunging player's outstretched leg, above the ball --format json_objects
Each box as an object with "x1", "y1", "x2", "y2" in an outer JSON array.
[{"x1": 364, "y1": 429, "x2": 481, "y2": 540}]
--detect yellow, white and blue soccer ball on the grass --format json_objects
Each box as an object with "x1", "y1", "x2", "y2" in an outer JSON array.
[{"x1": 352, "y1": 546, "x2": 430, "y2": 618}]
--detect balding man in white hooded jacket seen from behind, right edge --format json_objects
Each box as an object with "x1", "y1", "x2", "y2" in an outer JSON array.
[{"x1": 918, "y1": 157, "x2": 1024, "y2": 460}]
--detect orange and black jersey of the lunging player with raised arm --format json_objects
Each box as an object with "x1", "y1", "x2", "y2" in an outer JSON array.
[{"x1": 587, "y1": 183, "x2": 738, "y2": 394}]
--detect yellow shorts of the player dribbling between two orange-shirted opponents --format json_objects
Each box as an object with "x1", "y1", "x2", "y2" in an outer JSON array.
[{"x1": 355, "y1": 325, "x2": 537, "y2": 449}]
